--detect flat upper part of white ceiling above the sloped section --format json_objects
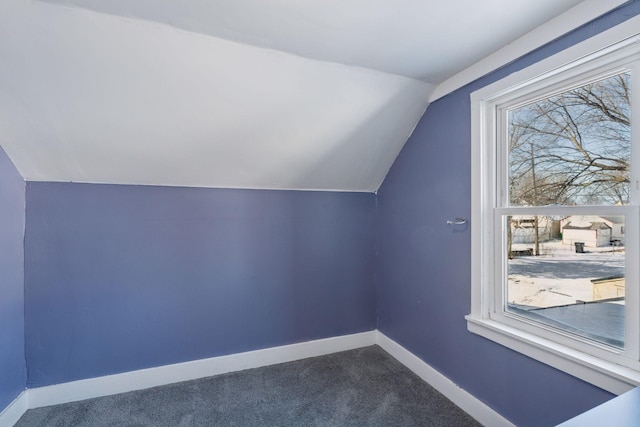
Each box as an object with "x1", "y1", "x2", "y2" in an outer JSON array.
[{"x1": 35, "y1": 0, "x2": 581, "y2": 84}]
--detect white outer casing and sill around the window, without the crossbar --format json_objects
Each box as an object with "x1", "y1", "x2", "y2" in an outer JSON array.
[{"x1": 466, "y1": 16, "x2": 640, "y2": 394}]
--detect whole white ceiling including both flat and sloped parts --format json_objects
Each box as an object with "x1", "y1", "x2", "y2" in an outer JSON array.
[{"x1": 0, "y1": 0, "x2": 620, "y2": 191}]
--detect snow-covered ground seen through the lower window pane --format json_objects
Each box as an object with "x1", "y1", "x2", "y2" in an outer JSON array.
[{"x1": 507, "y1": 240, "x2": 624, "y2": 307}]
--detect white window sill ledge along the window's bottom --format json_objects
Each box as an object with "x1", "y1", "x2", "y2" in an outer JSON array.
[{"x1": 466, "y1": 315, "x2": 640, "y2": 395}]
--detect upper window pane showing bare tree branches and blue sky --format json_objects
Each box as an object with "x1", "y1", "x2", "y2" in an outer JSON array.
[{"x1": 508, "y1": 72, "x2": 631, "y2": 206}]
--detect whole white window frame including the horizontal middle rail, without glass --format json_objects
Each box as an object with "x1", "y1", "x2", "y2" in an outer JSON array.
[{"x1": 466, "y1": 17, "x2": 640, "y2": 394}]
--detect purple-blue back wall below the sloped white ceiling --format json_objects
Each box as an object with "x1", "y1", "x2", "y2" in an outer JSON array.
[{"x1": 25, "y1": 182, "x2": 376, "y2": 387}]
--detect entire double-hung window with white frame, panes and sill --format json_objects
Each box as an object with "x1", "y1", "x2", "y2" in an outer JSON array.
[{"x1": 467, "y1": 25, "x2": 640, "y2": 393}]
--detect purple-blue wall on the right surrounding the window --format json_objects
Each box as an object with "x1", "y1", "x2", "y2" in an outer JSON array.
[{"x1": 377, "y1": 1, "x2": 640, "y2": 426}]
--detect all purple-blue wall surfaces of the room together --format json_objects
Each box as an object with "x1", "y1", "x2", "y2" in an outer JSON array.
[{"x1": 11, "y1": 1, "x2": 640, "y2": 426}]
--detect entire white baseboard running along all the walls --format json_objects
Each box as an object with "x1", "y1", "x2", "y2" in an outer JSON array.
[{"x1": 7, "y1": 330, "x2": 513, "y2": 427}]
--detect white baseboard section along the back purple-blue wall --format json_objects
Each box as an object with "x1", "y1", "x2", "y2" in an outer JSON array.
[{"x1": 27, "y1": 331, "x2": 376, "y2": 409}]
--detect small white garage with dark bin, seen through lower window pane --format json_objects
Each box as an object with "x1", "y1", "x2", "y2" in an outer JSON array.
[{"x1": 561, "y1": 215, "x2": 624, "y2": 248}]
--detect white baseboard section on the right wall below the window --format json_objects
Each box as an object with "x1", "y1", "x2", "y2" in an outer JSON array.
[{"x1": 376, "y1": 331, "x2": 514, "y2": 427}]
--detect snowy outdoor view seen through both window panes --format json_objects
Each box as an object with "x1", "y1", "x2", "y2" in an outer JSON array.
[{"x1": 498, "y1": 71, "x2": 631, "y2": 349}]
